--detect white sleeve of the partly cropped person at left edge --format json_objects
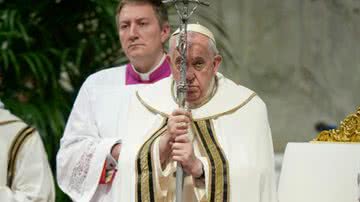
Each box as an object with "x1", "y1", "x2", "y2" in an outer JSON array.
[{"x1": 0, "y1": 132, "x2": 55, "y2": 202}]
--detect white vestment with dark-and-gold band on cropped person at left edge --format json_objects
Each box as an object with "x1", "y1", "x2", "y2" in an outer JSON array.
[{"x1": 0, "y1": 109, "x2": 55, "y2": 202}]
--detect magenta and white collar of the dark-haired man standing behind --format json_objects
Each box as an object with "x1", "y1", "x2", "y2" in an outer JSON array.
[{"x1": 126, "y1": 54, "x2": 171, "y2": 85}]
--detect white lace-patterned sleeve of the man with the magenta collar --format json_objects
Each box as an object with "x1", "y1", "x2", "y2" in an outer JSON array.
[{"x1": 56, "y1": 82, "x2": 118, "y2": 202}]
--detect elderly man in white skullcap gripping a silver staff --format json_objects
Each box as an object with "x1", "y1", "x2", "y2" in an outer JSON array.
[{"x1": 114, "y1": 24, "x2": 276, "y2": 202}]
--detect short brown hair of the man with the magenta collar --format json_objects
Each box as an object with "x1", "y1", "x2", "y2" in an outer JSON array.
[{"x1": 115, "y1": 0, "x2": 169, "y2": 28}]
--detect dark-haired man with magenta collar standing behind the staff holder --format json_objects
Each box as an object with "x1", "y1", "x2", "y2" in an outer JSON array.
[{"x1": 57, "y1": 0, "x2": 171, "y2": 202}]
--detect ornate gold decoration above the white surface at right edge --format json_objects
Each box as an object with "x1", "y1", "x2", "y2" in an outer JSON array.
[{"x1": 313, "y1": 107, "x2": 360, "y2": 143}]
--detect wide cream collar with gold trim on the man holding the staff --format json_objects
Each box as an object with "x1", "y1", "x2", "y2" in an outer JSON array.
[{"x1": 136, "y1": 73, "x2": 256, "y2": 121}]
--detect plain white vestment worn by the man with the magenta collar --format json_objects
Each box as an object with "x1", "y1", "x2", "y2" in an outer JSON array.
[{"x1": 57, "y1": 66, "x2": 139, "y2": 202}]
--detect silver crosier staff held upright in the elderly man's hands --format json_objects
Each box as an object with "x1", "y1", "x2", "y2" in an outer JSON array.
[{"x1": 162, "y1": 0, "x2": 210, "y2": 202}]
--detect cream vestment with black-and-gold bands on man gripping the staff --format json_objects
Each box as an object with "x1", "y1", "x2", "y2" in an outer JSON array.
[{"x1": 113, "y1": 74, "x2": 276, "y2": 202}]
